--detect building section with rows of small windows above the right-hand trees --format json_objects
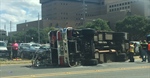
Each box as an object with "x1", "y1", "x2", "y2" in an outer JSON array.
[{"x1": 100, "y1": 0, "x2": 150, "y2": 30}]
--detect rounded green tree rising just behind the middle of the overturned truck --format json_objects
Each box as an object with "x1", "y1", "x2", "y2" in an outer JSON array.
[{"x1": 85, "y1": 18, "x2": 111, "y2": 31}]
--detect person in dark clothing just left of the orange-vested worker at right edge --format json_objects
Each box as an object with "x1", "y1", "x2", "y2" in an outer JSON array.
[{"x1": 141, "y1": 40, "x2": 148, "y2": 62}]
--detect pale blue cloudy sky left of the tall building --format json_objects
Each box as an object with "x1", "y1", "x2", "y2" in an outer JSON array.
[{"x1": 0, "y1": 0, "x2": 41, "y2": 32}]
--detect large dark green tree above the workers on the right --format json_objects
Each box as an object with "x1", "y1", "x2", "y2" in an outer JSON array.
[{"x1": 116, "y1": 15, "x2": 150, "y2": 40}]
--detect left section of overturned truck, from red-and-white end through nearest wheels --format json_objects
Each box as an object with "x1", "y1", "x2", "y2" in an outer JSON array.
[{"x1": 49, "y1": 27, "x2": 98, "y2": 66}]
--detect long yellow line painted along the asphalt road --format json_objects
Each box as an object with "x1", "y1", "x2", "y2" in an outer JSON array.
[{"x1": 1, "y1": 66, "x2": 150, "y2": 78}]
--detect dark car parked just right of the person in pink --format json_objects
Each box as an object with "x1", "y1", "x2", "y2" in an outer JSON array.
[{"x1": 18, "y1": 43, "x2": 37, "y2": 59}]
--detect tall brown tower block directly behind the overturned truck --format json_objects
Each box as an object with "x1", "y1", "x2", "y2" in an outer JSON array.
[{"x1": 40, "y1": 0, "x2": 106, "y2": 27}]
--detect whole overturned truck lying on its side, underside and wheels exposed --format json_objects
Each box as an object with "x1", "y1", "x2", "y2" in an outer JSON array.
[{"x1": 32, "y1": 27, "x2": 128, "y2": 67}]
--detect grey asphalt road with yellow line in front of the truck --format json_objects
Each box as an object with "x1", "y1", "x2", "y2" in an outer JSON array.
[{"x1": 0, "y1": 61, "x2": 150, "y2": 78}]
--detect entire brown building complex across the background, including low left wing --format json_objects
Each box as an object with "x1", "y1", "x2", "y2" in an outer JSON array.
[{"x1": 17, "y1": 0, "x2": 150, "y2": 31}]
